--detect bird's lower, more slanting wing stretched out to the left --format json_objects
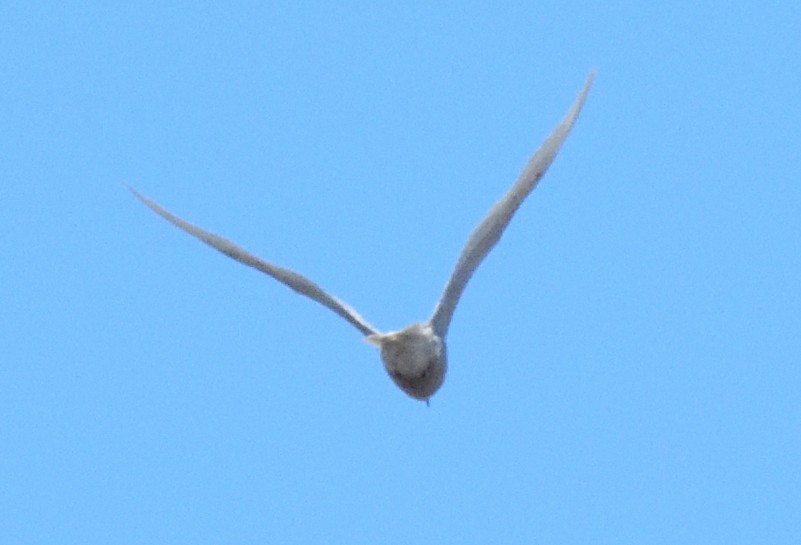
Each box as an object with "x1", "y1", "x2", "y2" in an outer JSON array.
[{"x1": 129, "y1": 188, "x2": 379, "y2": 335}]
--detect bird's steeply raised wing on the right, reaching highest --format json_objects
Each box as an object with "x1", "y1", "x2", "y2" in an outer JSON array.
[{"x1": 431, "y1": 72, "x2": 595, "y2": 338}]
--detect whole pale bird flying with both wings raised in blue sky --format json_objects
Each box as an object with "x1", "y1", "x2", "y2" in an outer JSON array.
[{"x1": 129, "y1": 71, "x2": 595, "y2": 404}]
